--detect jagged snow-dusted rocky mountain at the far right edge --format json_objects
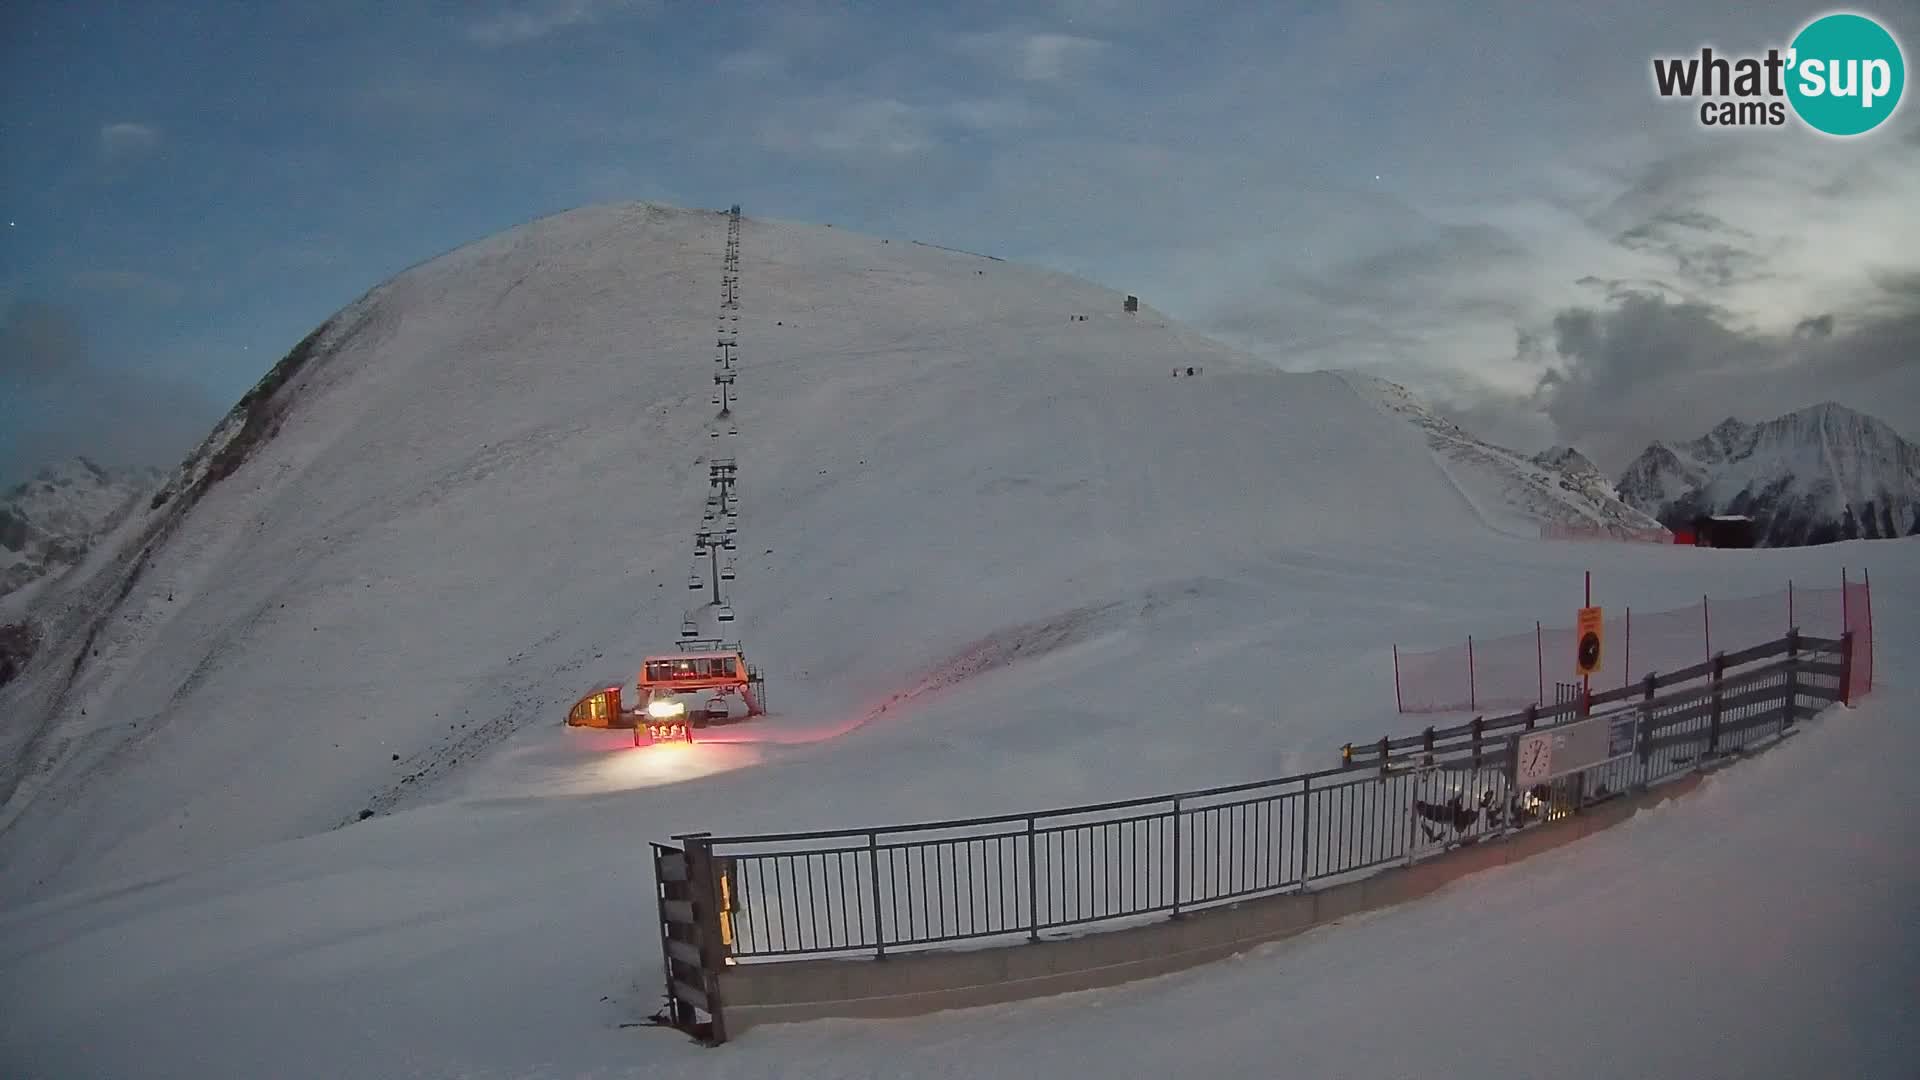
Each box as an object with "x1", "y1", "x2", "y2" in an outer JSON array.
[{"x1": 1620, "y1": 402, "x2": 1920, "y2": 548}]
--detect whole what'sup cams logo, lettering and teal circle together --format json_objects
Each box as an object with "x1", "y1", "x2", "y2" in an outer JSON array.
[{"x1": 1653, "y1": 13, "x2": 1907, "y2": 135}]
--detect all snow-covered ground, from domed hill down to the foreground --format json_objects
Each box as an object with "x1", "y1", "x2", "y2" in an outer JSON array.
[{"x1": 0, "y1": 206, "x2": 1920, "y2": 1078}]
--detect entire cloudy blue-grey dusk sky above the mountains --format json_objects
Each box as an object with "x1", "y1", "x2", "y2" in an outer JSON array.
[{"x1": 0, "y1": 0, "x2": 1920, "y2": 479}]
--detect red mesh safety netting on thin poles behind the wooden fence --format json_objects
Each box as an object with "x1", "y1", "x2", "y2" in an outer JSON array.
[{"x1": 1394, "y1": 569, "x2": 1874, "y2": 713}]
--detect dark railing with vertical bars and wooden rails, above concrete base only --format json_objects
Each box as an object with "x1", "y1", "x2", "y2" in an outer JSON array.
[{"x1": 678, "y1": 622, "x2": 1851, "y2": 963}]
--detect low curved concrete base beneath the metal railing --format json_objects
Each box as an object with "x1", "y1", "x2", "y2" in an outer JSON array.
[{"x1": 720, "y1": 773, "x2": 1701, "y2": 1034}]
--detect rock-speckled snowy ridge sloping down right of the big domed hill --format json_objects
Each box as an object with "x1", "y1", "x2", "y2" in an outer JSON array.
[{"x1": 1342, "y1": 373, "x2": 1661, "y2": 536}]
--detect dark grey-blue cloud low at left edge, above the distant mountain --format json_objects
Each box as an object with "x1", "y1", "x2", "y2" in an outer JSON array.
[{"x1": 0, "y1": 300, "x2": 221, "y2": 479}]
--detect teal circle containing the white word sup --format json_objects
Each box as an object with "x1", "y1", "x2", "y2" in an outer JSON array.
[{"x1": 1788, "y1": 13, "x2": 1907, "y2": 135}]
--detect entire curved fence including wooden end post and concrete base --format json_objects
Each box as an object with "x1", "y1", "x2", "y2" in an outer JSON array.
[{"x1": 653, "y1": 632, "x2": 1853, "y2": 1043}]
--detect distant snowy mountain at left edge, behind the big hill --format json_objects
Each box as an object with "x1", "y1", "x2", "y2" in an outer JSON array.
[{"x1": 0, "y1": 457, "x2": 163, "y2": 611}]
